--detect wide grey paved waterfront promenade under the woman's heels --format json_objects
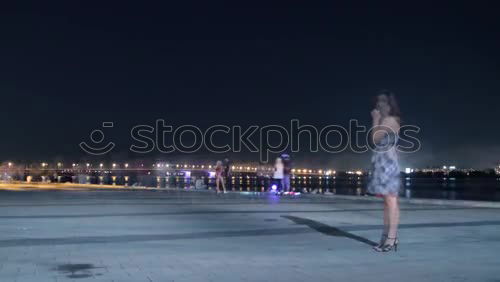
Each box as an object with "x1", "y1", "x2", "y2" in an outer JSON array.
[{"x1": 0, "y1": 187, "x2": 500, "y2": 282}]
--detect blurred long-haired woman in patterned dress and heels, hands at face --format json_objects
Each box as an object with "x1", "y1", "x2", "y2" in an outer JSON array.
[{"x1": 368, "y1": 90, "x2": 401, "y2": 252}]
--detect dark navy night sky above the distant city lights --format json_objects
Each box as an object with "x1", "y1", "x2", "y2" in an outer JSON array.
[{"x1": 0, "y1": 1, "x2": 500, "y2": 168}]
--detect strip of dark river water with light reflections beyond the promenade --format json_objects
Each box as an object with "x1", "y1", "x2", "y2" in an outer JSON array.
[{"x1": 26, "y1": 173, "x2": 500, "y2": 201}]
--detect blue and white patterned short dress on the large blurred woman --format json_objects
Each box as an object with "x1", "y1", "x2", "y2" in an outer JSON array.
[{"x1": 368, "y1": 133, "x2": 401, "y2": 196}]
